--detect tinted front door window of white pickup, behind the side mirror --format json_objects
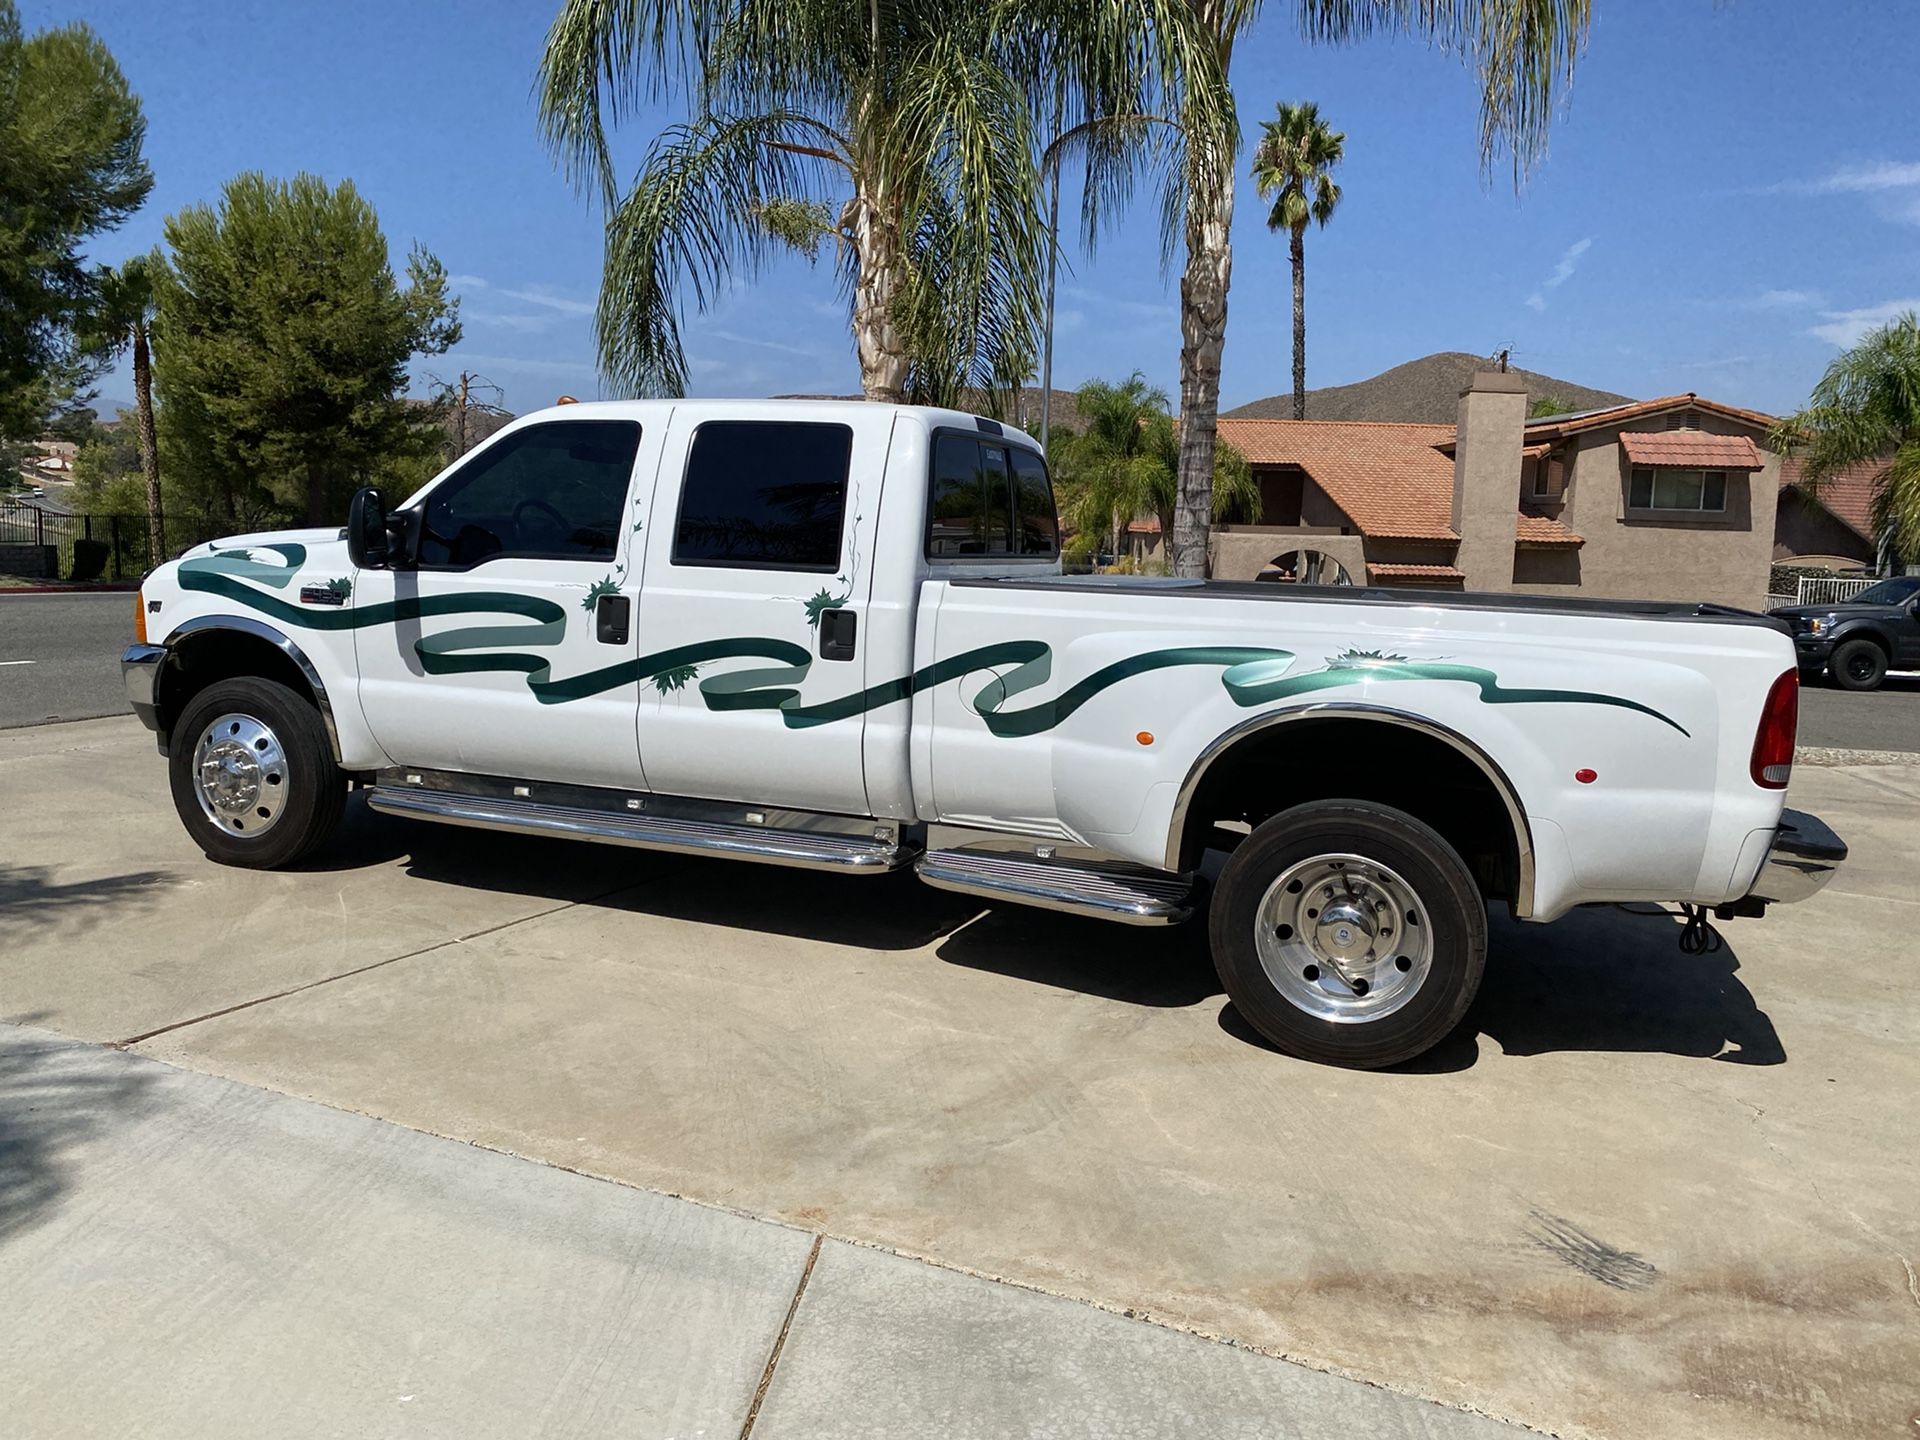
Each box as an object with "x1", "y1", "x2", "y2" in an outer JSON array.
[{"x1": 420, "y1": 420, "x2": 639, "y2": 570}]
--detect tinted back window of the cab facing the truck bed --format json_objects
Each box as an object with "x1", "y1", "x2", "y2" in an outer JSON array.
[{"x1": 927, "y1": 434, "x2": 1058, "y2": 561}]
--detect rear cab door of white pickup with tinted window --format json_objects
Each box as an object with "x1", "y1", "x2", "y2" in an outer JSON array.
[{"x1": 637, "y1": 405, "x2": 895, "y2": 814}]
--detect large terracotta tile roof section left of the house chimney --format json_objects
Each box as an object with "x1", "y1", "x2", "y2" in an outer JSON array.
[{"x1": 1219, "y1": 419, "x2": 1459, "y2": 540}]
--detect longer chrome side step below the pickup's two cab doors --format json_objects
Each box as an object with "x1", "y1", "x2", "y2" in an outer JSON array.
[{"x1": 367, "y1": 785, "x2": 916, "y2": 876}]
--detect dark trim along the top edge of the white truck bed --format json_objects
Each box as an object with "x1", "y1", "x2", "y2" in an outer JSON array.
[{"x1": 947, "y1": 576, "x2": 1791, "y2": 636}]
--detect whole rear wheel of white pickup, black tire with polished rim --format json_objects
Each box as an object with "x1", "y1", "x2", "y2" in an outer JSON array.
[{"x1": 1208, "y1": 801, "x2": 1486, "y2": 1069}]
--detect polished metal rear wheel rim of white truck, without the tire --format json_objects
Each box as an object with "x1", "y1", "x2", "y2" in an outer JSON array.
[{"x1": 1254, "y1": 854, "x2": 1434, "y2": 1023}]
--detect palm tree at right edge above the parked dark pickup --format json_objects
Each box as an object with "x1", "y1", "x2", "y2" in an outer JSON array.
[{"x1": 1770, "y1": 311, "x2": 1920, "y2": 559}]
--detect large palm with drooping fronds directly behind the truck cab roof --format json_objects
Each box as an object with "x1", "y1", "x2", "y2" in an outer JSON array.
[{"x1": 540, "y1": 0, "x2": 1041, "y2": 399}]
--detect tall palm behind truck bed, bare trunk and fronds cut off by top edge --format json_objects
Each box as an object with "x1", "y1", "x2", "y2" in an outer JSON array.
[{"x1": 1004, "y1": 0, "x2": 1594, "y2": 576}]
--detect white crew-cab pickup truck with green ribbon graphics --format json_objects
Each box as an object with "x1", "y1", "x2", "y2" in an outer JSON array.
[{"x1": 123, "y1": 401, "x2": 1845, "y2": 1066}]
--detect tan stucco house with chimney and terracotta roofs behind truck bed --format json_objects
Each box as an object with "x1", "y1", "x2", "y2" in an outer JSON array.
[{"x1": 1212, "y1": 374, "x2": 1780, "y2": 609}]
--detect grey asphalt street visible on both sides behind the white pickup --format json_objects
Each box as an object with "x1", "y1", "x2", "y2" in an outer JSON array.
[{"x1": 0, "y1": 595, "x2": 1920, "y2": 753}]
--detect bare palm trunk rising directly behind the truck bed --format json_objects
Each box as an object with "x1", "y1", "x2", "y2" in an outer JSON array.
[{"x1": 1169, "y1": 156, "x2": 1233, "y2": 578}]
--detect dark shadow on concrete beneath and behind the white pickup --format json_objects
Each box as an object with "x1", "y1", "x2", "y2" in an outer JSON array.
[{"x1": 301, "y1": 799, "x2": 1786, "y2": 1073}]
